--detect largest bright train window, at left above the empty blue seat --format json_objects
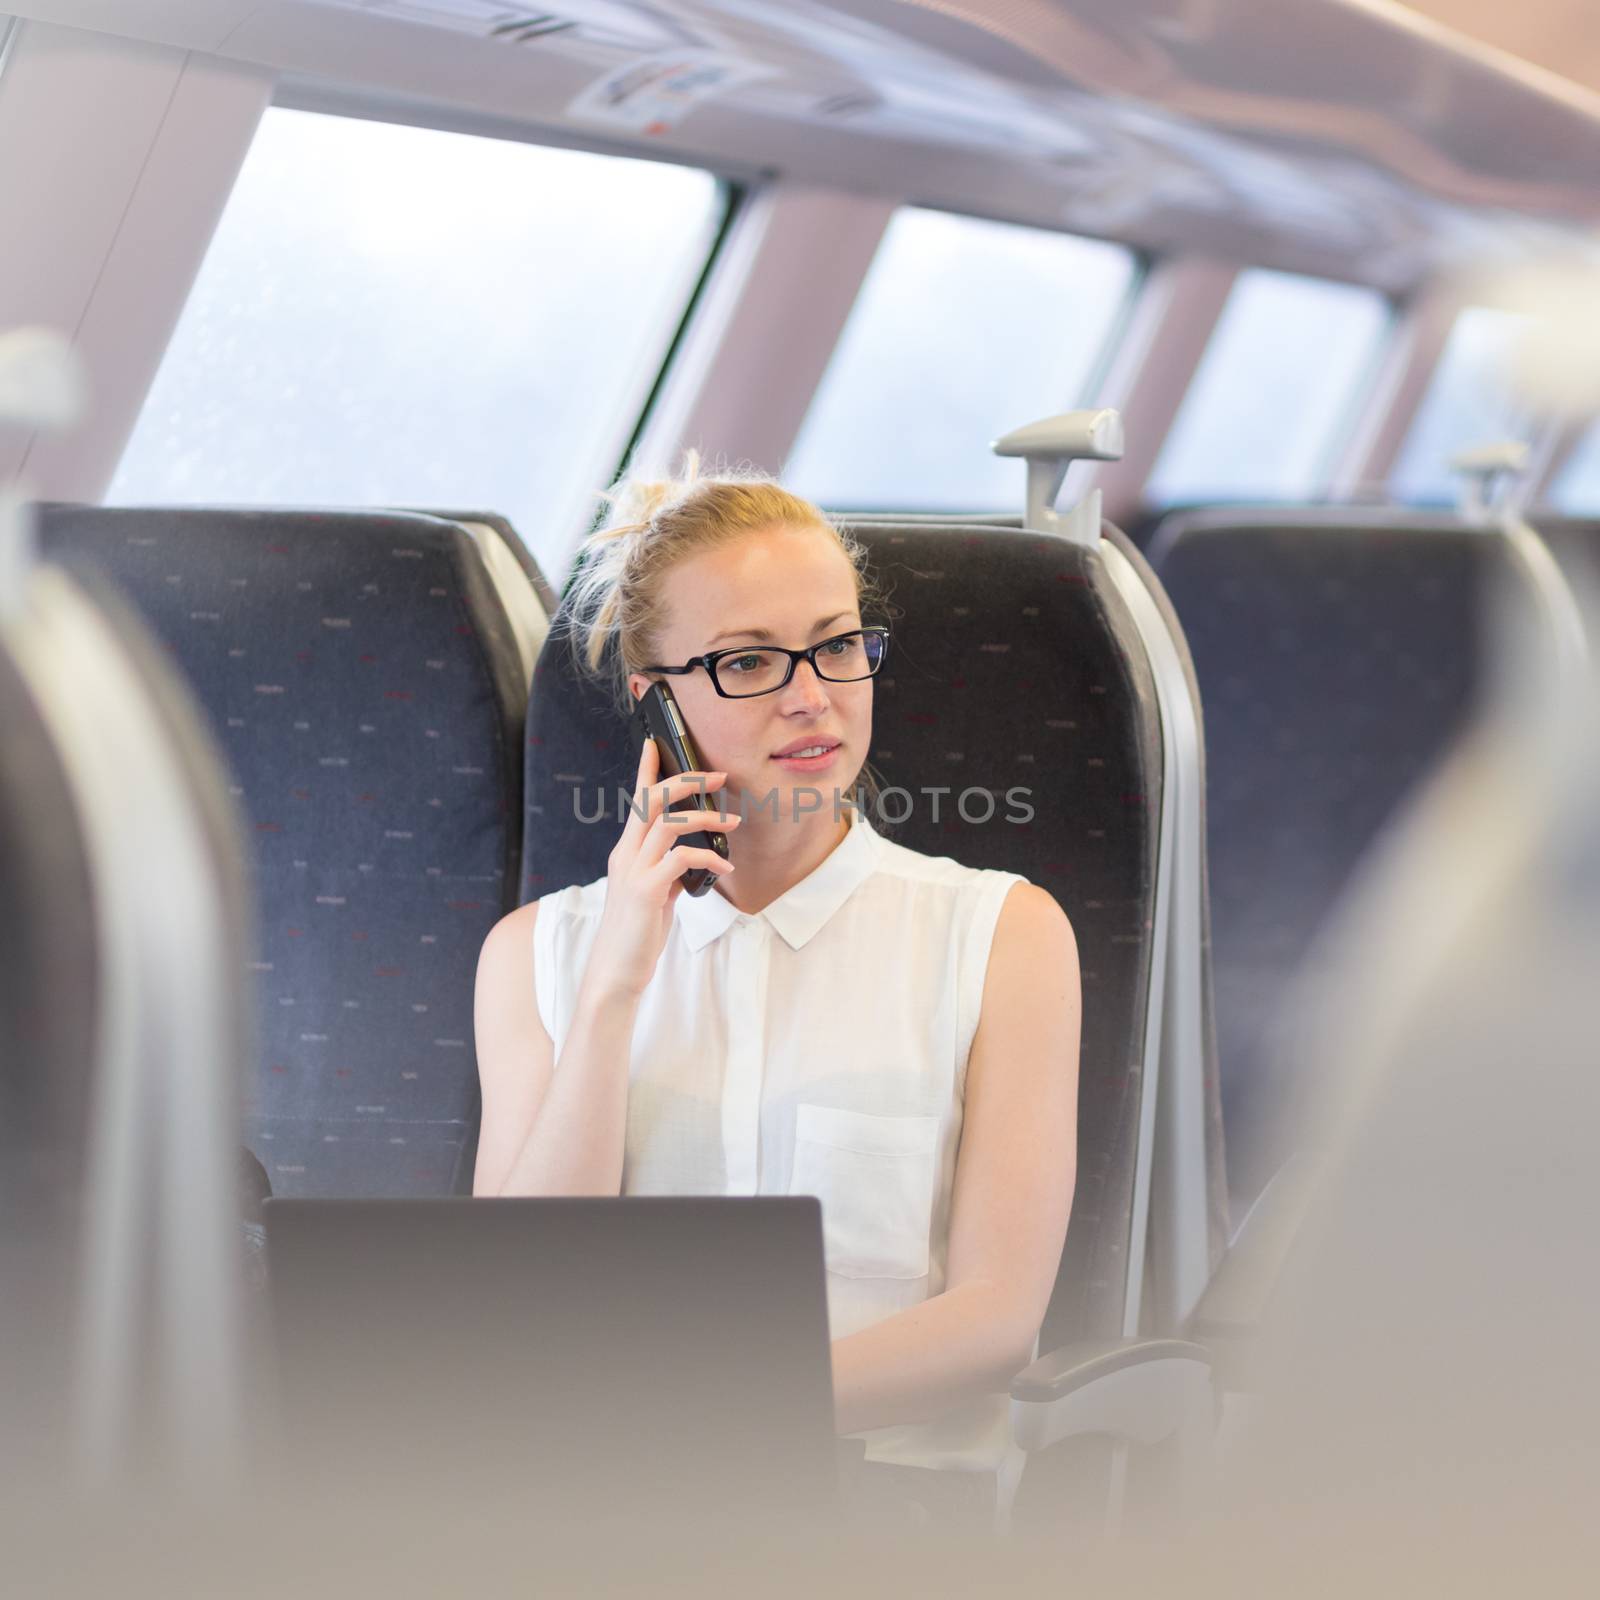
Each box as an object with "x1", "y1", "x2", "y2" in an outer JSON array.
[{"x1": 107, "y1": 107, "x2": 728, "y2": 570}]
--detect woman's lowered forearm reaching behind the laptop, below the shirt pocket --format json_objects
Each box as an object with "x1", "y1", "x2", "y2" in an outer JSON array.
[{"x1": 832, "y1": 1280, "x2": 1037, "y2": 1434}]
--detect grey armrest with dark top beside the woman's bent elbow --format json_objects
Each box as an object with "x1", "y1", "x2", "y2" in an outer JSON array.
[{"x1": 1011, "y1": 1339, "x2": 1211, "y2": 1450}]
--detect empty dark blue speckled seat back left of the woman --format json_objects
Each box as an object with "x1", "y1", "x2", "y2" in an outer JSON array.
[{"x1": 40, "y1": 506, "x2": 525, "y2": 1197}]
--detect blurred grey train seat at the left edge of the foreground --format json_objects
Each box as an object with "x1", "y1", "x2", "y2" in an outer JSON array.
[{"x1": 0, "y1": 524, "x2": 251, "y2": 1484}]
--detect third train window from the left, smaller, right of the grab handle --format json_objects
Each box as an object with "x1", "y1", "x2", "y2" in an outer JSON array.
[{"x1": 1146, "y1": 269, "x2": 1390, "y2": 506}]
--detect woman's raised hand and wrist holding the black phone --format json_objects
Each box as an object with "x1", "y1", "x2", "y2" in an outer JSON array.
[{"x1": 584, "y1": 739, "x2": 744, "y2": 995}]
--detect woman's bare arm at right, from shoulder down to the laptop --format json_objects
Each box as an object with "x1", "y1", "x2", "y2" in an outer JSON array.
[{"x1": 834, "y1": 883, "x2": 1082, "y2": 1434}]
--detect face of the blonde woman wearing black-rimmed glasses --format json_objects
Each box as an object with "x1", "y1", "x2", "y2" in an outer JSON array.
[{"x1": 629, "y1": 525, "x2": 872, "y2": 827}]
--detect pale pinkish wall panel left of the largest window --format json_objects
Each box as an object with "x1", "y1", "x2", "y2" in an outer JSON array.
[{"x1": 0, "y1": 22, "x2": 274, "y2": 499}]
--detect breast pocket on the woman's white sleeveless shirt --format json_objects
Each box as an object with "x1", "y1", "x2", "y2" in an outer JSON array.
[{"x1": 789, "y1": 1104, "x2": 939, "y2": 1278}]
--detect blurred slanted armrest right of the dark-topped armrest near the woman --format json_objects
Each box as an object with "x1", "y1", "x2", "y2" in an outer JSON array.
[{"x1": 1187, "y1": 1152, "x2": 1318, "y2": 1390}]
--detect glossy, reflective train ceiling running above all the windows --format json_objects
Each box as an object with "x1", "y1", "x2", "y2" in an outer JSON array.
[{"x1": 9, "y1": 0, "x2": 1600, "y2": 288}]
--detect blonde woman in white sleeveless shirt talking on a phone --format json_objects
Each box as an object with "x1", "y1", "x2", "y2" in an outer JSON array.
[{"x1": 474, "y1": 458, "x2": 1080, "y2": 1523}]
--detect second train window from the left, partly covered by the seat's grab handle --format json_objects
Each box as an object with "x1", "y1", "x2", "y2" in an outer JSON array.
[{"x1": 787, "y1": 206, "x2": 1138, "y2": 510}]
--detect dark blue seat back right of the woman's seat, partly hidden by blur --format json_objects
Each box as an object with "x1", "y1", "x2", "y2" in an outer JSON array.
[{"x1": 1152, "y1": 510, "x2": 1509, "y2": 1216}]
